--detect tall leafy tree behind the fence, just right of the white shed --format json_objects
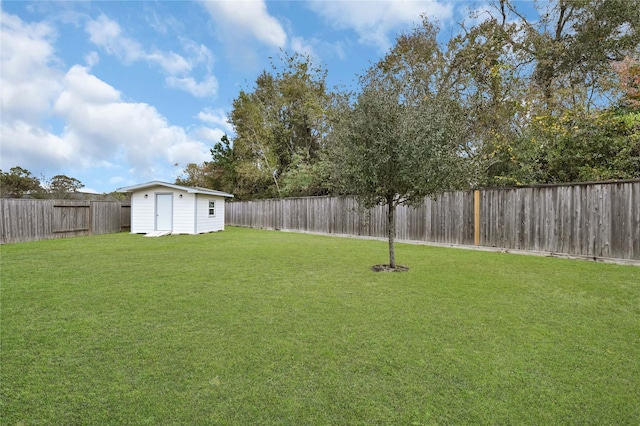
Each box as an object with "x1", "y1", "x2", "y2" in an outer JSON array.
[{"x1": 229, "y1": 54, "x2": 332, "y2": 198}]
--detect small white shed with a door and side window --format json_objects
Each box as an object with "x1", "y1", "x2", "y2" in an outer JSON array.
[{"x1": 116, "y1": 181, "x2": 233, "y2": 234}]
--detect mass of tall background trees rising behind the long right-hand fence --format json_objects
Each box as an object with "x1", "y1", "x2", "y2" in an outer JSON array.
[{"x1": 180, "y1": 0, "x2": 640, "y2": 199}]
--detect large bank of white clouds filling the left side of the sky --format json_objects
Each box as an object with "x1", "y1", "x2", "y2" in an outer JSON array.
[{"x1": 0, "y1": 13, "x2": 211, "y2": 187}]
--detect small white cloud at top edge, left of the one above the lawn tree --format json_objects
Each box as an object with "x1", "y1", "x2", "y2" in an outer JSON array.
[{"x1": 202, "y1": 0, "x2": 287, "y2": 48}]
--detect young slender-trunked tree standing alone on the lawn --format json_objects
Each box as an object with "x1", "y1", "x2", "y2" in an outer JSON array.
[{"x1": 332, "y1": 21, "x2": 473, "y2": 269}]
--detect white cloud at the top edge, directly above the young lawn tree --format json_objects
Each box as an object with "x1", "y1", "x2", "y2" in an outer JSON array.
[{"x1": 311, "y1": 0, "x2": 453, "y2": 51}]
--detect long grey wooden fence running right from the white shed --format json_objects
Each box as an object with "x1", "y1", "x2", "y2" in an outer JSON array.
[{"x1": 225, "y1": 180, "x2": 640, "y2": 260}]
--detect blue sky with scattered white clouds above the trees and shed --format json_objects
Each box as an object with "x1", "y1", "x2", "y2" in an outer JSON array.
[{"x1": 0, "y1": 0, "x2": 512, "y2": 193}]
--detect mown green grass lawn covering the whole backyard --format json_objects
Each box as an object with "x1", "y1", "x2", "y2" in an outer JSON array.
[{"x1": 0, "y1": 228, "x2": 640, "y2": 425}]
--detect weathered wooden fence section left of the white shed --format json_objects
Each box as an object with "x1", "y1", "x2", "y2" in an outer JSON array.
[{"x1": 0, "y1": 198, "x2": 131, "y2": 244}]
